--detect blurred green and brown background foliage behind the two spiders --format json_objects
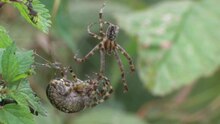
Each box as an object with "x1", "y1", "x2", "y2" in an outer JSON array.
[{"x1": 0, "y1": 0, "x2": 220, "y2": 124}]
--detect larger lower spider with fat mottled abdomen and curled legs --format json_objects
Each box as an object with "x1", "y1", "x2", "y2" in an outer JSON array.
[{"x1": 35, "y1": 53, "x2": 113, "y2": 113}]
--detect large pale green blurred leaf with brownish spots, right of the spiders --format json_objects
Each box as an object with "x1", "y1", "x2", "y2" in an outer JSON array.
[{"x1": 118, "y1": 0, "x2": 220, "y2": 95}]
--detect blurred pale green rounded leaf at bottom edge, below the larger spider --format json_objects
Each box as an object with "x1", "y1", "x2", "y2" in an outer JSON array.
[{"x1": 74, "y1": 108, "x2": 147, "y2": 124}]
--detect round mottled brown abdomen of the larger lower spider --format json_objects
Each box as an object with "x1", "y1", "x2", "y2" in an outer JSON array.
[{"x1": 46, "y1": 79, "x2": 88, "y2": 113}]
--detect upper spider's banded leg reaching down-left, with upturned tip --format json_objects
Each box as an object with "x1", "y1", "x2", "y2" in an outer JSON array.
[{"x1": 73, "y1": 44, "x2": 101, "y2": 63}]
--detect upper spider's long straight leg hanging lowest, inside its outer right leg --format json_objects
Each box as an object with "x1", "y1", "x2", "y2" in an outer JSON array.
[{"x1": 114, "y1": 51, "x2": 128, "y2": 92}]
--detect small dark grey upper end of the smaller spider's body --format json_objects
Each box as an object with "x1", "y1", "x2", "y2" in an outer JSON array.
[{"x1": 106, "y1": 25, "x2": 119, "y2": 41}]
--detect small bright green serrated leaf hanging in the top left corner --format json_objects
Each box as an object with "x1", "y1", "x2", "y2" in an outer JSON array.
[{"x1": 13, "y1": 0, "x2": 51, "y2": 33}]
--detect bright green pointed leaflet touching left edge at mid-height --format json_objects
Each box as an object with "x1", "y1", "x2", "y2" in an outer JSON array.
[{"x1": 1, "y1": 44, "x2": 19, "y2": 83}]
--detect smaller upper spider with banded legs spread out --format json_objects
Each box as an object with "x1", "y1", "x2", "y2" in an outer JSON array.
[{"x1": 74, "y1": 3, "x2": 135, "y2": 92}]
